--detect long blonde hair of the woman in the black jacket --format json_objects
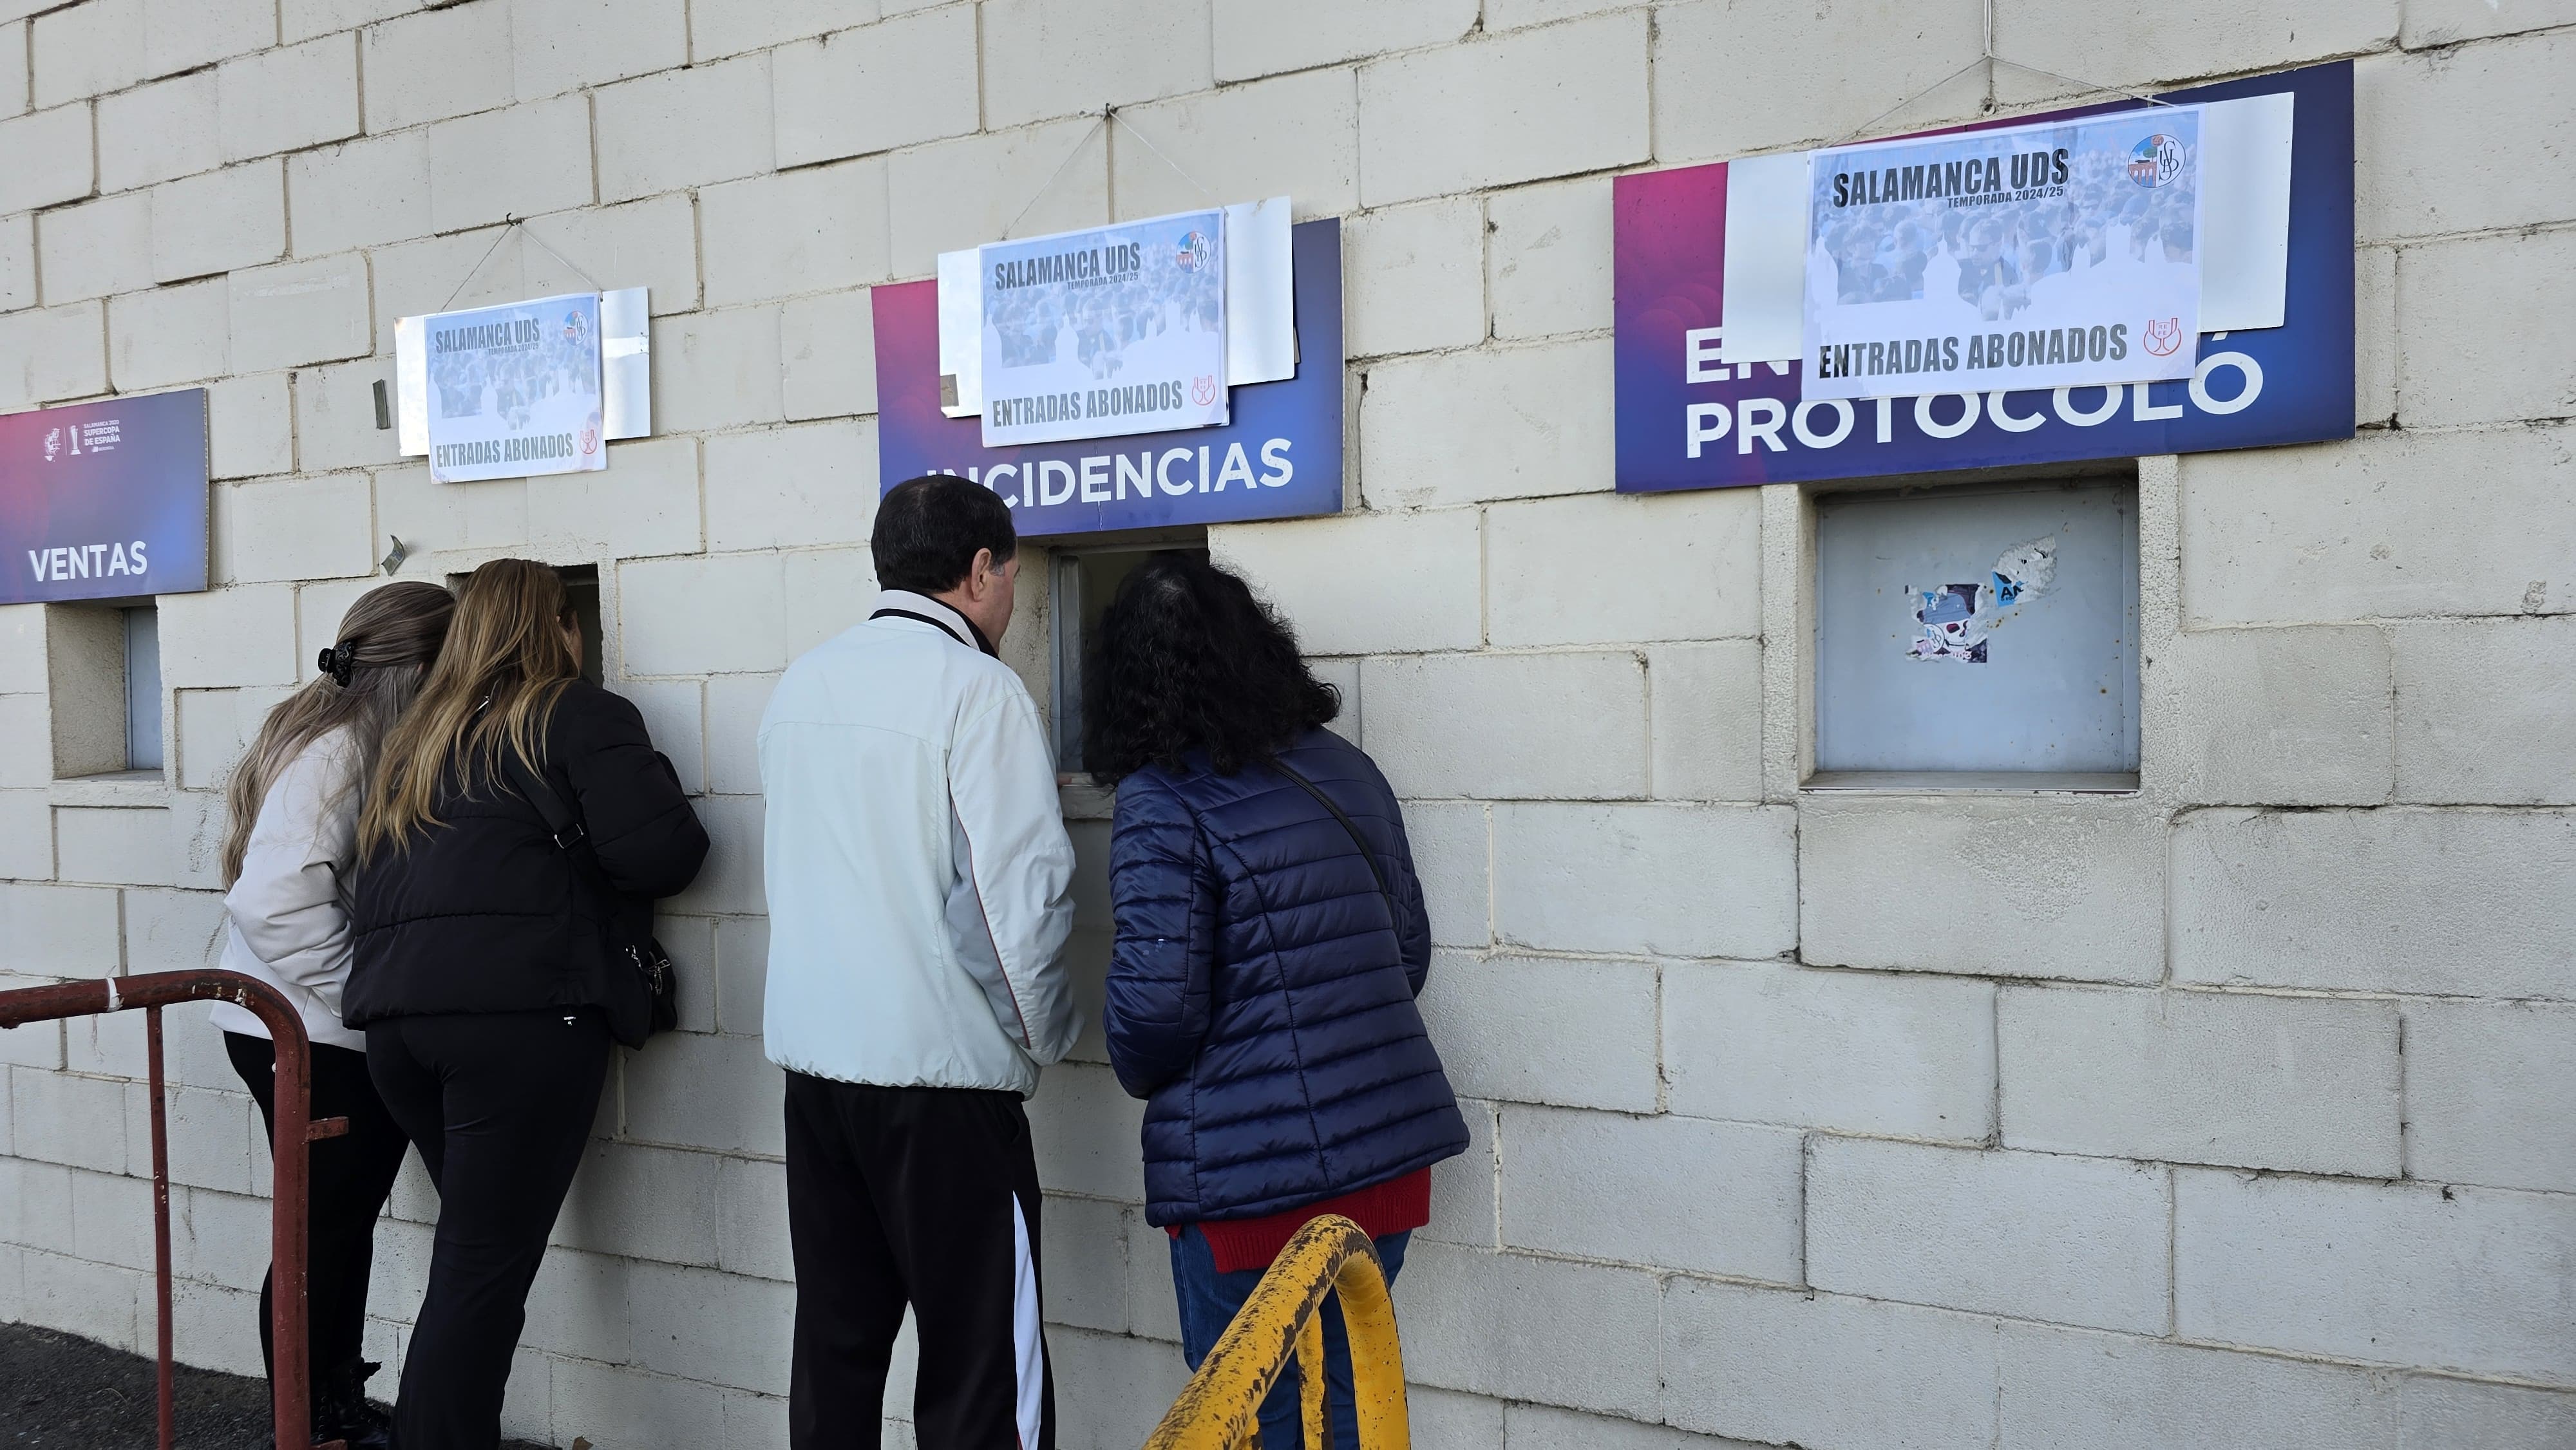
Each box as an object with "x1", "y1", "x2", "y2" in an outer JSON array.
[{"x1": 358, "y1": 559, "x2": 582, "y2": 860}]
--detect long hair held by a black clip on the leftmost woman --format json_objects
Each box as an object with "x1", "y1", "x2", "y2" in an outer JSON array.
[{"x1": 224, "y1": 579, "x2": 456, "y2": 889}]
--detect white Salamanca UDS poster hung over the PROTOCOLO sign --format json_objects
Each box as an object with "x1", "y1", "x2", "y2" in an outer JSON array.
[{"x1": 1801, "y1": 106, "x2": 2202, "y2": 399}]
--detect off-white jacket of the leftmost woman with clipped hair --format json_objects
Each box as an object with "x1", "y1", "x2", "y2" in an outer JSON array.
[{"x1": 224, "y1": 737, "x2": 358, "y2": 1015}]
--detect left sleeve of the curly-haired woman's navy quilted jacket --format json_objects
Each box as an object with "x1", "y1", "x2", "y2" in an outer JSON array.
[{"x1": 1105, "y1": 775, "x2": 1216, "y2": 1097}]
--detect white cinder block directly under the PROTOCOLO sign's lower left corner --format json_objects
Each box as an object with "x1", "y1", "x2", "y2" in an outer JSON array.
[{"x1": 1484, "y1": 487, "x2": 1762, "y2": 646}]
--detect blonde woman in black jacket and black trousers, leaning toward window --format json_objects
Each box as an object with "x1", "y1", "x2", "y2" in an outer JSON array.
[{"x1": 343, "y1": 559, "x2": 706, "y2": 1450}]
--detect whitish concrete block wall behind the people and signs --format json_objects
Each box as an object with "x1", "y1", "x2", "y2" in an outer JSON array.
[{"x1": 0, "y1": 0, "x2": 2576, "y2": 1450}]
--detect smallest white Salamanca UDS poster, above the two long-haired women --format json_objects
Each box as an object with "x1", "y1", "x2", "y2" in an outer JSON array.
[{"x1": 422, "y1": 291, "x2": 608, "y2": 484}]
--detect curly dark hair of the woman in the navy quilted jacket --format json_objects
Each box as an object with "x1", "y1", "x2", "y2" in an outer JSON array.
[{"x1": 1082, "y1": 554, "x2": 1342, "y2": 786}]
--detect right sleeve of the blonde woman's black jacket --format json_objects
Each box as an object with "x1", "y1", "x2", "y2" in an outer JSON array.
[{"x1": 546, "y1": 683, "x2": 706, "y2": 896}]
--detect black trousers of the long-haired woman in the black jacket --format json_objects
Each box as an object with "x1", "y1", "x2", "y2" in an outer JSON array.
[{"x1": 366, "y1": 1010, "x2": 608, "y2": 1450}]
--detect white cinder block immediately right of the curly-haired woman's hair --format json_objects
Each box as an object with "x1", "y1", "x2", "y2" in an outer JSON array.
[{"x1": 1360, "y1": 654, "x2": 1646, "y2": 801}]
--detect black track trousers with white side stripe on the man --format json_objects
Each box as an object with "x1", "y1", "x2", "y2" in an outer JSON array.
[{"x1": 793, "y1": 1071, "x2": 1056, "y2": 1450}]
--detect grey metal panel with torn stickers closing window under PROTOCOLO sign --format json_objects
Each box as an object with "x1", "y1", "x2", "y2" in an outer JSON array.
[{"x1": 1816, "y1": 484, "x2": 2138, "y2": 773}]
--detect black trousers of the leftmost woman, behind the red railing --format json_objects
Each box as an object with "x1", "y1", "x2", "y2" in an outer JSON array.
[{"x1": 224, "y1": 1033, "x2": 410, "y2": 1398}]
